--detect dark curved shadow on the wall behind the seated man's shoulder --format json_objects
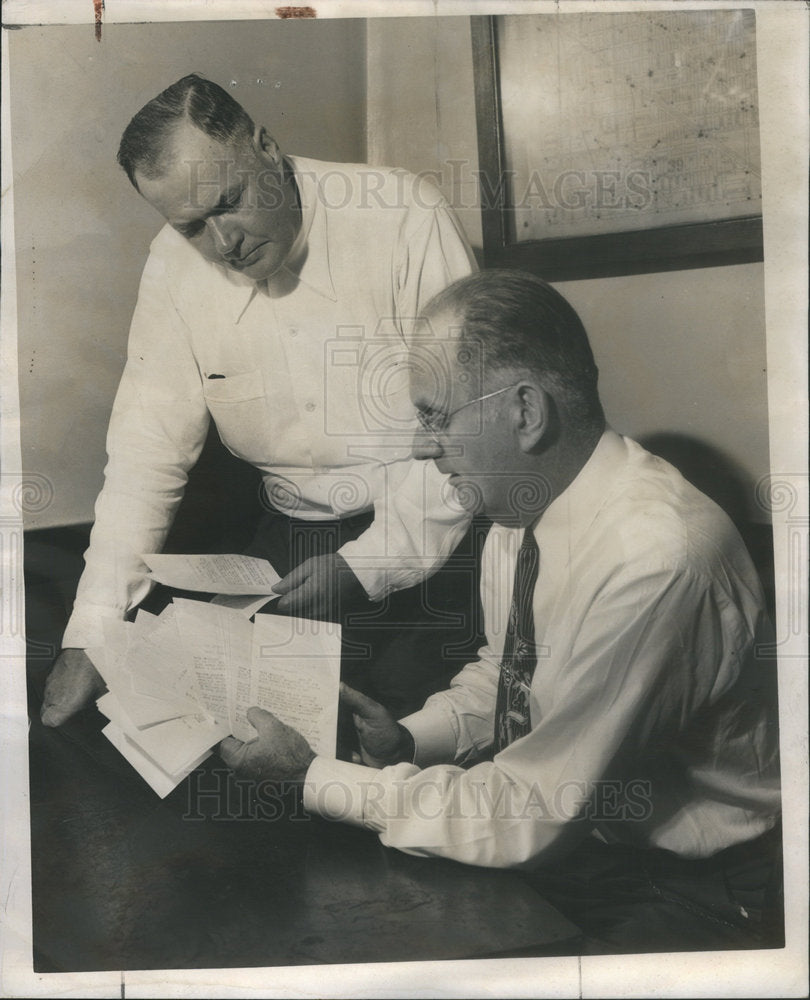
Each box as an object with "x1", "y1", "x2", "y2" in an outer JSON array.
[{"x1": 639, "y1": 432, "x2": 776, "y2": 621}]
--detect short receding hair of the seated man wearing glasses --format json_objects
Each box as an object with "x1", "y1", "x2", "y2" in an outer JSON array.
[{"x1": 425, "y1": 269, "x2": 605, "y2": 433}]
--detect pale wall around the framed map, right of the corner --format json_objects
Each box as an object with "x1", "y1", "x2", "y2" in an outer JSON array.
[{"x1": 367, "y1": 17, "x2": 769, "y2": 520}]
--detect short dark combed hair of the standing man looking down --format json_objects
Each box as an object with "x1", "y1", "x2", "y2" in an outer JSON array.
[{"x1": 118, "y1": 73, "x2": 255, "y2": 188}]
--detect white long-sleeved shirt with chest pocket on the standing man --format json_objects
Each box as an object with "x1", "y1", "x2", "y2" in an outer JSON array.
[{"x1": 68, "y1": 157, "x2": 475, "y2": 648}]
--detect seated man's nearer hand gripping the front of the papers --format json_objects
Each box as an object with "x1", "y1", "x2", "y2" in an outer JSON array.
[{"x1": 219, "y1": 707, "x2": 315, "y2": 781}]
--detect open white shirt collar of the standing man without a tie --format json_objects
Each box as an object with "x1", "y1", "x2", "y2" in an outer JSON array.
[{"x1": 230, "y1": 156, "x2": 337, "y2": 323}]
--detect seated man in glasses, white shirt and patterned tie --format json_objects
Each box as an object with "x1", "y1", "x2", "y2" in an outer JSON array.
[{"x1": 220, "y1": 271, "x2": 780, "y2": 951}]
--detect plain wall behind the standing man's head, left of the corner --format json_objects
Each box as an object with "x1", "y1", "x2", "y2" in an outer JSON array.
[{"x1": 11, "y1": 20, "x2": 365, "y2": 527}]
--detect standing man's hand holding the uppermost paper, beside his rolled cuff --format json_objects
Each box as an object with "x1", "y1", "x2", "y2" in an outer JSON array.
[{"x1": 273, "y1": 552, "x2": 365, "y2": 621}]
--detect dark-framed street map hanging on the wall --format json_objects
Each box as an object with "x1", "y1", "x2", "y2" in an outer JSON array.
[{"x1": 473, "y1": 10, "x2": 762, "y2": 280}]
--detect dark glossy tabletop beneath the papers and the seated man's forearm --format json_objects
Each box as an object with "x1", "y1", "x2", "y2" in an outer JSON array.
[{"x1": 30, "y1": 666, "x2": 576, "y2": 972}]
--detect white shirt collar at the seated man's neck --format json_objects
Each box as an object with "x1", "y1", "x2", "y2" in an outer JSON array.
[{"x1": 534, "y1": 427, "x2": 627, "y2": 552}]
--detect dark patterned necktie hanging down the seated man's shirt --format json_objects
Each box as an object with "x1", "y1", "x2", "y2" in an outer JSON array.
[{"x1": 495, "y1": 528, "x2": 540, "y2": 753}]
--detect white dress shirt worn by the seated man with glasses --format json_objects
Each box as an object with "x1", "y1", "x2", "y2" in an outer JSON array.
[{"x1": 304, "y1": 430, "x2": 779, "y2": 867}]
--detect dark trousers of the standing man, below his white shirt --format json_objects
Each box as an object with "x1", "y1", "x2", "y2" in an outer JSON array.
[{"x1": 246, "y1": 512, "x2": 489, "y2": 755}]
